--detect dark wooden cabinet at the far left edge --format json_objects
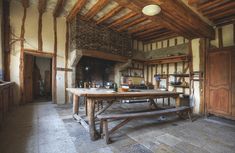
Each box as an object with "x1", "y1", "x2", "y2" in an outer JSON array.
[{"x1": 0, "y1": 81, "x2": 15, "y2": 127}]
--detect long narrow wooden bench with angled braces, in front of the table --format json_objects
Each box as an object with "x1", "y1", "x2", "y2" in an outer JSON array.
[{"x1": 97, "y1": 106, "x2": 192, "y2": 144}]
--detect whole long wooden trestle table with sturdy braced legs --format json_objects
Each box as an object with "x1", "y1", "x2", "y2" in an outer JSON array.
[{"x1": 66, "y1": 88, "x2": 181, "y2": 140}]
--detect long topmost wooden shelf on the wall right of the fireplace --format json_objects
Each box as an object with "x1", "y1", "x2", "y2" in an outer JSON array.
[{"x1": 145, "y1": 55, "x2": 191, "y2": 65}]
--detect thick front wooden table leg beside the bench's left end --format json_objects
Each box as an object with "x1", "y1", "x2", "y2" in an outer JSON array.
[{"x1": 87, "y1": 98, "x2": 98, "y2": 141}]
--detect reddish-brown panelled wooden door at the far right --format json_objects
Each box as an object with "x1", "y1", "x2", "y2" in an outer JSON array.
[{"x1": 206, "y1": 51, "x2": 231, "y2": 116}]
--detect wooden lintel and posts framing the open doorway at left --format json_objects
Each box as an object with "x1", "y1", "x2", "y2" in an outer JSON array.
[{"x1": 22, "y1": 49, "x2": 56, "y2": 103}]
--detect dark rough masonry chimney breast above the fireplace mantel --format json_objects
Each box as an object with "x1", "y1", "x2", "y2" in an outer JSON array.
[{"x1": 70, "y1": 16, "x2": 132, "y2": 57}]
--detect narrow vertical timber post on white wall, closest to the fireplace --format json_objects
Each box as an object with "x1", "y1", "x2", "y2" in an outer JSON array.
[{"x1": 64, "y1": 22, "x2": 69, "y2": 103}]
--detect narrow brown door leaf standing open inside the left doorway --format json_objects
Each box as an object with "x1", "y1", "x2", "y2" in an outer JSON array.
[{"x1": 24, "y1": 54, "x2": 34, "y2": 103}]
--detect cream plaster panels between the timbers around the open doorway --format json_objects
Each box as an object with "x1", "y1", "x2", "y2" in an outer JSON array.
[{"x1": 10, "y1": 0, "x2": 71, "y2": 104}]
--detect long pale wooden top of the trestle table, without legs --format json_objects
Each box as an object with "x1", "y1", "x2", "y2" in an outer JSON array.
[{"x1": 66, "y1": 88, "x2": 181, "y2": 98}]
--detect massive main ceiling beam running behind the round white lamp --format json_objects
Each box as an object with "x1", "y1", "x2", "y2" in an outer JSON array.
[{"x1": 115, "y1": 0, "x2": 214, "y2": 38}]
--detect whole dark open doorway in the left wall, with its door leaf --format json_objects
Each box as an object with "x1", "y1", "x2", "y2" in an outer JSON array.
[{"x1": 24, "y1": 54, "x2": 52, "y2": 103}]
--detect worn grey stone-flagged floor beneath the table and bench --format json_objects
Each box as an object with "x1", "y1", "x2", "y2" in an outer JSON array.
[{"x1": 0, "y1": 103, "x2": 235, "y2": 153}]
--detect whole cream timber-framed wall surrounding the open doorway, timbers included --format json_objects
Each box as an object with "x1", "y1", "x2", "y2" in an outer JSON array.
[{"x1": 3, "y1": 0, "x2": 71, "y2": 104}]
